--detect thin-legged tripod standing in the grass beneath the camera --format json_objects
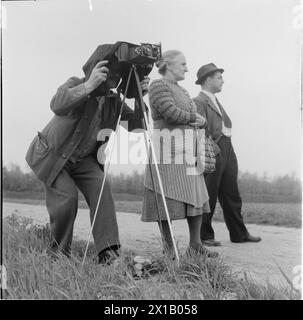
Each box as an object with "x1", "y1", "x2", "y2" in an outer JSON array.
[{"x1": 82, "y1": 64, "x2": 180, "y2": 267}]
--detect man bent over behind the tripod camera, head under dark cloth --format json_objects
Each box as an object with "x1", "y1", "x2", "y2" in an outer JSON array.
[{"x1": 26, "y1": 45, "x2": 149, "y2": 264}]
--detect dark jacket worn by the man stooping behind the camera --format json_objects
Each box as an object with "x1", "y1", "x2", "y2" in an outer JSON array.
[{"x1": 26, "y1": 47, "x2": 147, "y2": 186}]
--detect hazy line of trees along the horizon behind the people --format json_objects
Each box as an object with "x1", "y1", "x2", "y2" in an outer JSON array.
[{"x1": 2, "y1": 164, "x2": 302, "y2": 202}]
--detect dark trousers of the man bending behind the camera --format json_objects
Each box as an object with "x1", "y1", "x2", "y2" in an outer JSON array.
[{"x1": 45, "y1": 156, "x2": 120, "y2": 255}]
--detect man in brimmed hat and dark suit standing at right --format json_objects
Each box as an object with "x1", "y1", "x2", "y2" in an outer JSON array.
[{"x1": 194, "y1": 63, "x2": 261, "y2": 246}]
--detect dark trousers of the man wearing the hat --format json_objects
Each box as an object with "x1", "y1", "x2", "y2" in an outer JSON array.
[{"x1": 201, "y1": 136, "x2": 248, "y2": 242}]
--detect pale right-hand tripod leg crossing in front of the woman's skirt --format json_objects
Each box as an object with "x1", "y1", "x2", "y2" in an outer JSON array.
[{"x1": 134, "y1": 67, "x2": 180, "y2": 264}]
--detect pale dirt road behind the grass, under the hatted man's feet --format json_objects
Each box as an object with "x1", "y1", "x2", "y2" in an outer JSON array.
[{"x1": 3, "y1": 202, "x2": 301, "y2": 285}]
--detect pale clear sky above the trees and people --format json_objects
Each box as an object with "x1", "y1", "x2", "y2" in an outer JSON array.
[{"x1": 1, "y1": 0, "x2": 302, "y2": 176}]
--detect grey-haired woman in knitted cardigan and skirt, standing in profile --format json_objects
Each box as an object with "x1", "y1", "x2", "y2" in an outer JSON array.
[{"x1": 142, "y1": 50, "x2": 218, "y2": 257}]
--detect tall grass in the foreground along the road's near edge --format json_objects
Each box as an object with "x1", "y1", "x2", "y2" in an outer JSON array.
[{"x1": 3, "y1": 216, "x2": 300, "y2": 300}]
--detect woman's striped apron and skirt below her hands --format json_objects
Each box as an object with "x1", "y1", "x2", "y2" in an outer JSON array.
[{"x1": 141, "y1": 128, "x2": 210, "y2": 221}]
